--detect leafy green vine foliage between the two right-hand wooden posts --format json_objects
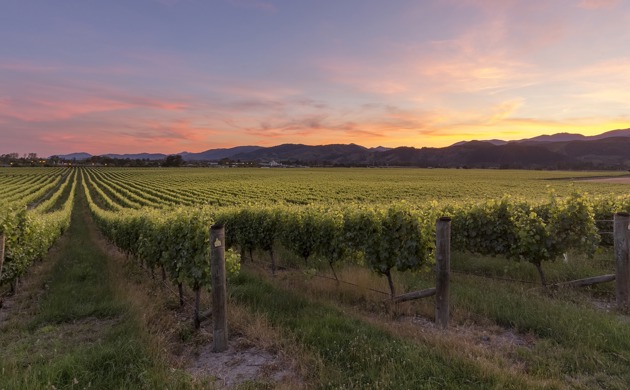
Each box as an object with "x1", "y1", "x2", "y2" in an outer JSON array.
[{"x1": 447, "y1": 191, "x2": 599, "y2": 284}]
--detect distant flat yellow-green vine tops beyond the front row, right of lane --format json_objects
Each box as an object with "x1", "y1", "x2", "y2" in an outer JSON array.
[{"x1": 82, "y1": 168, "x2": 628, "y2": 205}]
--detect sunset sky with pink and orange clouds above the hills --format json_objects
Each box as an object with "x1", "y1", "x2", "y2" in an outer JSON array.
[{"x1": 0, "y1": 0, "x2": 630, "y2": 156}]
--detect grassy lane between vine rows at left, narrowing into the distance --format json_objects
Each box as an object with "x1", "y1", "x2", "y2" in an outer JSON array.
[{"x1": 0, "y1": 181, "x2": 189, "y2": 390}]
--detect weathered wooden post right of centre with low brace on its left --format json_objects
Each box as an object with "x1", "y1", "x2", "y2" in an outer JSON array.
[{"x1": 435, "y1": 217, "x2": 451, "y2": 329}]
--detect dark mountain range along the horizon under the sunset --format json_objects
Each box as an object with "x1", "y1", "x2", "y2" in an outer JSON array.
[{"x1": 59, "y1": 129, "x2": 630, "y2": 169}]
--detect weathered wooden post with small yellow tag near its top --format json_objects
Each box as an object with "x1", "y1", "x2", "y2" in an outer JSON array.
[{"x1": 210, "y1": 225, "x2": 228, "y2": 352}]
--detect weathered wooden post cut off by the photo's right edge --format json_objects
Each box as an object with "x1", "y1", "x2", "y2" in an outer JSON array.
[{"x1": 614, "y1": 213, "x2": 630, "y2": 310}]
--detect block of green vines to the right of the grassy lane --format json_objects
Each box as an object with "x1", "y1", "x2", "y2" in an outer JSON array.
[{"x1": 81, "y1": 168, "x2": 630, "y2": 297}]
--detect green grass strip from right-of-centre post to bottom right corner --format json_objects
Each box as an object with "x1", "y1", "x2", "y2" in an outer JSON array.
[{"x1": 452, "y1": 276, "x2": 630, "y2": 389}]
